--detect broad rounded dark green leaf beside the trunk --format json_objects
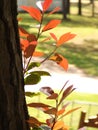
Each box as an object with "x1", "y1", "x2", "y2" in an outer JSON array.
[{"x1": 24, "y1": 73, "x2": 41, "y2": 85}]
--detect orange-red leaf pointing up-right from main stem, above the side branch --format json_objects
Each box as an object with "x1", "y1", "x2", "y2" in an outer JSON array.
[{"x1": 42, "y1": 20, "x2": 61, "y2": 32}]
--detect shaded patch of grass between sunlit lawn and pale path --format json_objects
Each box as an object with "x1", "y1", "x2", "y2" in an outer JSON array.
[{"x1": 38, "y1": 40, "x2": 98, "y2": 76}]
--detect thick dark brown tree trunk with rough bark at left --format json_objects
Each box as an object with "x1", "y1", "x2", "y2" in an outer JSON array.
[{"x1": 0, "y1": 0, "x2": 29, "y2": 130}]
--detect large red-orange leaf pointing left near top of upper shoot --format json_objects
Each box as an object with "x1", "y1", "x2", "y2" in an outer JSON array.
[{"x1": 21, "y1": 6, "x2": 41, "y2": 22}]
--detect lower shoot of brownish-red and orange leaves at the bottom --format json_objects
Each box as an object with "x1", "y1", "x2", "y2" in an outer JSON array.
[{"x1": 27, "y1": 81, "x2": 80, "y2": 130}]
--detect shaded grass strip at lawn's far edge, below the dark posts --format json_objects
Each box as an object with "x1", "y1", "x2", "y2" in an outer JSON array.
[{"x1": 18, "y1": 13, "x2": 98, "y2": 28}]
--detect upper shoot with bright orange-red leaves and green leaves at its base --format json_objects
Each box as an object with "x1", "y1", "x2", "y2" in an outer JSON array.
[{"x1": 19, "y1": 0, "x2": 76, "y2": 84}]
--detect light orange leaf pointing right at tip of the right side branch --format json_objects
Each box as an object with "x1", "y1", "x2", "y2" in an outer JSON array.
[{"x1": 57, "y1": 32, "x2": 76, "y2": 46}]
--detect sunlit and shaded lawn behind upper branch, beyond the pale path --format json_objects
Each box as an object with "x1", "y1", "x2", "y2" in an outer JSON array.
[{"x1": 19, "y1": 13, "x2": 98, "y2": 77}]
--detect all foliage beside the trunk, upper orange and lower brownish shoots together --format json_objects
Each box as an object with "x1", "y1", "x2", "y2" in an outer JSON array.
[{"x1": 19, "y1": 0, "x2": 79, "y2": 130}]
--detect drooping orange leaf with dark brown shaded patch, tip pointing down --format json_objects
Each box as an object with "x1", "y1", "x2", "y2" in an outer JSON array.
[{"x1": 50, "y1": 53, "x2": 68, "y2": 71}]
